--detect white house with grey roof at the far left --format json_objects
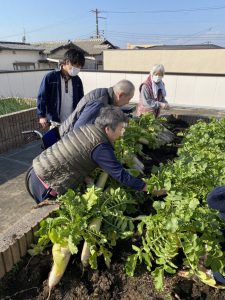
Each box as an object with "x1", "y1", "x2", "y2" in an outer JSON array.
[{"x1": 0, "y1": 41, "x2": 44, "y2": 71}]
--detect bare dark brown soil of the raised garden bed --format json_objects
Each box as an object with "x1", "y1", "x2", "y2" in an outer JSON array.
[{"x1": 0, "y1": 117, "x2": 225, "y2": 300}]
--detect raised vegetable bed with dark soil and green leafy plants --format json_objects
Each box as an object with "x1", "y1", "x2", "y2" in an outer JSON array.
[{"x1": 0, "y1": 113, "x2": 225, "y2": 300}]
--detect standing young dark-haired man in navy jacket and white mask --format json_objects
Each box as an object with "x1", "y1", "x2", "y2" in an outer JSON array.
[{"x1": 37, "y1": 49, "x2": 85, "y2": 128}]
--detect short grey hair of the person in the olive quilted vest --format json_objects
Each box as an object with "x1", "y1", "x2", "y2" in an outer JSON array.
[{"x1": 95, "y1": 105, "x2": 128, "y2": 131}]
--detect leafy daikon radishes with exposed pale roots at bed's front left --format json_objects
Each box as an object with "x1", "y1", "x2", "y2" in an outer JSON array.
[{"x1": 30, "y1": 176, "x2": 136, "y2": 291}]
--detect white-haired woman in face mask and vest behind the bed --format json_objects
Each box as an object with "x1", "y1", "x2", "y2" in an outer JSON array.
[{"x1": 136, "y1": 64, "x2": 169, "y2": 118}]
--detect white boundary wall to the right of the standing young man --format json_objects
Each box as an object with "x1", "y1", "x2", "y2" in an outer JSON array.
[{"x1": 80, "y1": 72, "x2": 225, "y2": 108}]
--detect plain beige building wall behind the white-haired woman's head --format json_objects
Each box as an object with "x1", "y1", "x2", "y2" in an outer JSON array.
[{"x1": 103, "y1": 49, "x2": 225, "y2": 74}]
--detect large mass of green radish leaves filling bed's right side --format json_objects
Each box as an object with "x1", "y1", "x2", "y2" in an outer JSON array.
[{"x1": 126, "y1": 119, "x2": 225, "y2": 289}]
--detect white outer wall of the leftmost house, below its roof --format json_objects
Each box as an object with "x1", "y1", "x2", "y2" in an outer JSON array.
[{"x1": 0, "y1": 50, "x2": 42, "y2": 71}]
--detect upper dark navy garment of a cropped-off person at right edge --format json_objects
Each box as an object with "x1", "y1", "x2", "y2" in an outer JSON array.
[{"x1": 206, "y1": 185, "x2": 225, "y2": 219}]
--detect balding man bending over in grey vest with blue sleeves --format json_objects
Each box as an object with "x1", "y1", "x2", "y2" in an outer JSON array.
[{"x1": 59, "y1": 79, "x2": 135, "y2": 136}]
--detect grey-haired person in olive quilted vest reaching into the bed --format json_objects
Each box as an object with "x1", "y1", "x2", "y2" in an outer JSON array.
[{"x1": 30, "y1": 106, "x2": 147, "y2": 203}]
